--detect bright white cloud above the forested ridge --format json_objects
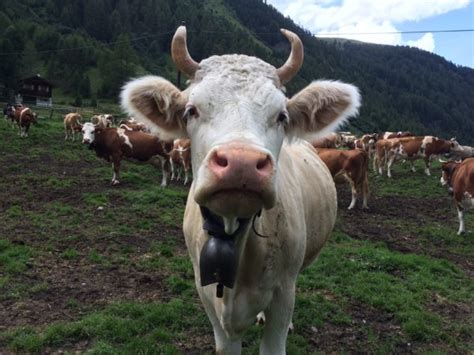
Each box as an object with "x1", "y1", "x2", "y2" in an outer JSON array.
[{"x1": 268, "y1": 0, "x2": 470, "y2": 51}]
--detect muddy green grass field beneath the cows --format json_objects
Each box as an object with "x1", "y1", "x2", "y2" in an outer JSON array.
[{"x1": 0, "y1": 111, "x2": 474, "y2": 354}]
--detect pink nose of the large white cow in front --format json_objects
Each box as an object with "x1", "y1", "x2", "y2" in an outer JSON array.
[{"x1": 209, "y1": 148, "x2": 273, "y2": 180}]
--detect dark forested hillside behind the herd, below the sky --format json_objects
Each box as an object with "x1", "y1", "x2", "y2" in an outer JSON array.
[{"x1": 0, "y1": 0, "x2": 474, "y2": 144}]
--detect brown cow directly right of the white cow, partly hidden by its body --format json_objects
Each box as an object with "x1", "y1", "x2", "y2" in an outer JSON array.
[{"x1": 316, "y1": 148, "x2": 369, "y2": 210}]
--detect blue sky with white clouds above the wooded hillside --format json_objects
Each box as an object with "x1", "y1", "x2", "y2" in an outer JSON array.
[{"x1": 267, "y1": 0, "x2": 474, "y2": 68}]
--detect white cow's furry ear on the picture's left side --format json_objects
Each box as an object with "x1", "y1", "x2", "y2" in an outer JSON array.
[{"x1": 120, "y1": 76, "x2": 187, "y2": 139}]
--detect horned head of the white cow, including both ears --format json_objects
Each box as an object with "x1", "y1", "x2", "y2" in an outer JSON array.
[{"x1": 121, "y1": 26, "x2": 360, "y2": 229}]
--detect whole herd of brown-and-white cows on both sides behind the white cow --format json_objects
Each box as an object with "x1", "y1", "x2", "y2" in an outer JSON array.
[{"x1": 4, "y1": 105, "x2": 474, "y2": 234}]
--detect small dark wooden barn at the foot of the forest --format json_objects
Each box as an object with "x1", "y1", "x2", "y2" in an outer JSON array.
[{"x1": 17, "y1": 74, "x2": 53, "y2": 107}]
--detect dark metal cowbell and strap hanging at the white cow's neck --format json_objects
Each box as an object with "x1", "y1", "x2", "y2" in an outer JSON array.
[{"x1": 199, "y1": 206, "x2": 250, "y2": 298}]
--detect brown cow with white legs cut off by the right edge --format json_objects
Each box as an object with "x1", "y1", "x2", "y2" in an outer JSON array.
[{"x1": 441, "y1": 158, "x2": 474, "y2": 235}]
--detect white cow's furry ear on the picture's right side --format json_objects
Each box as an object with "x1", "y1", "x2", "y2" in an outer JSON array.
[{"x1": 287, "y1": 81, "x2": 360, "y2": 137}]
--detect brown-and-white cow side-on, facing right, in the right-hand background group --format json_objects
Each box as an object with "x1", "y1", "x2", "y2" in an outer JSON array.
[{"x1": 386, "y1": 136, "x2": 459, "y2": 177}]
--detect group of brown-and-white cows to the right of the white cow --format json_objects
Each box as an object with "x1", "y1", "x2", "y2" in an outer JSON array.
[{"x1": 312, "y1": 132, "x2": 474, "y2": 234}]
